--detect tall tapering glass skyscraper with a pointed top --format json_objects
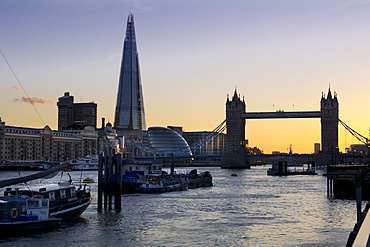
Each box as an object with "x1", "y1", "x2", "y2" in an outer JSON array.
[{"x1": 114, "y1": 13, "x2": 146, "y2": 130}]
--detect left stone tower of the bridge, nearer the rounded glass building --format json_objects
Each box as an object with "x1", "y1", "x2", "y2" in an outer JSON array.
[{"x1": 221, "y1": 89, "x2": 248, "y2": 168}]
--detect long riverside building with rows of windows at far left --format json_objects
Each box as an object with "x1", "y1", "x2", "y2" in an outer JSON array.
[{"x1": 0, "y1": 118, "x2": 98, "y2": 161}]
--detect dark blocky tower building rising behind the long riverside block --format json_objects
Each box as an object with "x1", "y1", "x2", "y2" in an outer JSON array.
[{"x1": 57, "y1": 92, "x2": 98, "y2": 131}]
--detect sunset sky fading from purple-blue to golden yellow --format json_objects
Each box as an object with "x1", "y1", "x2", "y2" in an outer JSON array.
[{"x1": 0, "y1": 0, "x2": 370, "y2": 153}]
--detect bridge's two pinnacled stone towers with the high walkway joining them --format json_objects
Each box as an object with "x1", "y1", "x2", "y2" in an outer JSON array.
[{"x1": 221, "y1": 88, "x2": 339, "y2": 168}]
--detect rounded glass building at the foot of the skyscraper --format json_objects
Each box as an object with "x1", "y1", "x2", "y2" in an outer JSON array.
[{"x1": 148, "y1": 127, "x2": 192, "y2": 155}]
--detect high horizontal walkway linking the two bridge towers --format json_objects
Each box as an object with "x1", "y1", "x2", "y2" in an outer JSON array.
[{"x1": 241, "y1": 111, "x2": 321, "y2": 119}]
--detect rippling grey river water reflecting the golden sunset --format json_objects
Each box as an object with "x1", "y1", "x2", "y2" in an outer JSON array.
[{"x1": 0, "y1": 166, "x2": 356, "y2": 247}]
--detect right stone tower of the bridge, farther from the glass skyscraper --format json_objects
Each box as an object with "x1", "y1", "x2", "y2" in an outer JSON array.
[{"x1": 321, "y1": 87, "x2": 339, "y2": 154}]
